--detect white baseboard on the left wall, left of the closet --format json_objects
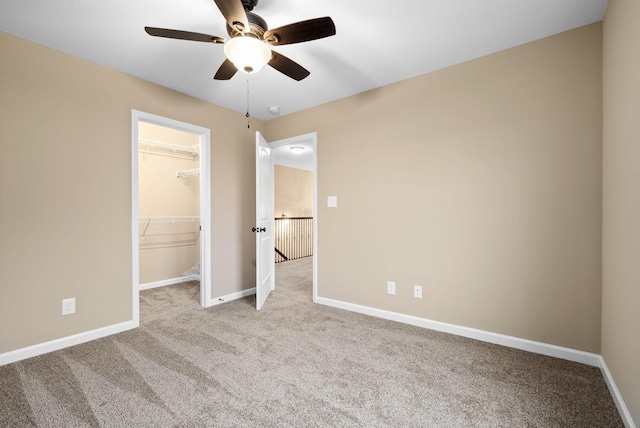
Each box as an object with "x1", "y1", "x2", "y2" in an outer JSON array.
[{"x1": 0, "y1": 321, "x2": 135, "y2": 366}]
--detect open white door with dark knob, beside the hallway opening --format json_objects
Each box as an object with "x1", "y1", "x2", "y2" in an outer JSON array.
[{"x1": 253, "y1": 132, "x2": 275, "y2": 309}]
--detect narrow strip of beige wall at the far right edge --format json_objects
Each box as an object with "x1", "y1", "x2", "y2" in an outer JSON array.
[{"x1": 602, "y1": 0, "x2": 640, "y2": 426}]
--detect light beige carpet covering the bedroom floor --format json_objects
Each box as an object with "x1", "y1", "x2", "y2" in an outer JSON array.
[{"x1": 0, "y1": 259, "x2": 623, "y2": 427}]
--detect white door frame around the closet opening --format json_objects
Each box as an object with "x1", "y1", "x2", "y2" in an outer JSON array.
[{"x1": 131, "y1": 110, "x2": 213, "y2": 327}]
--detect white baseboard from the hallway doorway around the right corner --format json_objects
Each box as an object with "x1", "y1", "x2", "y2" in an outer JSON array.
[{"x1": 315, "y1": 297, "x2": 636, "y2": 428}]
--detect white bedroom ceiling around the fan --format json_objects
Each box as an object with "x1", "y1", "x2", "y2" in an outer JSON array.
[{"x1": 0, "y1": 0, "x2": 608, "y2": 120}]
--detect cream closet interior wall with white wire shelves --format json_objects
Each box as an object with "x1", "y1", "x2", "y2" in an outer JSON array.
[{"x1": 138, "y1": 123, "x2": 200, "y2": 286}]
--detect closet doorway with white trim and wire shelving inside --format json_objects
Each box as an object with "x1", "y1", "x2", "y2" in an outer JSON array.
[{"x1": 131, "y1": 110, "x2": 211, "y2": 326}]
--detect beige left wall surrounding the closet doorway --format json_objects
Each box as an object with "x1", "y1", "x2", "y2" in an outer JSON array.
[{"x1": 0, "y1": 32, "x2": 262, "y2": 353}]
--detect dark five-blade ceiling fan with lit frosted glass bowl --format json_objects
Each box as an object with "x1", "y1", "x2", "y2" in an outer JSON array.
[{"x1": 144, "y1": 0, "x2": 336, "y2": 81}]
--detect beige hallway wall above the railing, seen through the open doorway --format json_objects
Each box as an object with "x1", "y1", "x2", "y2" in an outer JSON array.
[{"x1": 274, "y1": 165, "x2": 313, "y2": 217}]
